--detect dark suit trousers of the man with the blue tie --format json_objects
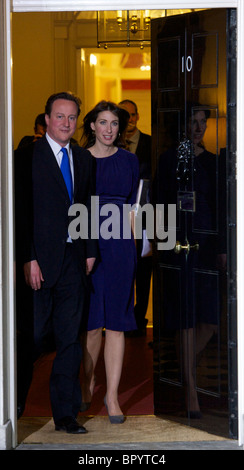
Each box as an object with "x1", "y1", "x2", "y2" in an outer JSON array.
[{"x1": 34, "y1": 243, "x2": 85, "y2": 422}]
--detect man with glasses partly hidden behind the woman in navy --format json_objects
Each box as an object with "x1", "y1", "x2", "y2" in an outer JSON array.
[{"x1": 119, "y1": 99, "x2": 152, "y2": 336}]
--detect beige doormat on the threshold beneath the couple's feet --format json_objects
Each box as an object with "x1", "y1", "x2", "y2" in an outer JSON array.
[{"x1": 23, "y1": 416, "x2": 224, "y2": 444}]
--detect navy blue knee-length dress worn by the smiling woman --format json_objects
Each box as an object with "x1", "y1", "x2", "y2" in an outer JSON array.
[{"x1": 87, "y1": 149, "x2": 139, "y2": 331}]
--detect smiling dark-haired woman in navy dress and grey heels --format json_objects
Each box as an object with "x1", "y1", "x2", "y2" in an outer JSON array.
[{"x1": 81, "y1": 101, "x2": 139, "y2": 423}]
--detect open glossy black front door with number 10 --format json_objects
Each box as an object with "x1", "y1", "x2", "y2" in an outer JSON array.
[{"x1": 152, "y1": 9, "x2": 237, "y2": 437}]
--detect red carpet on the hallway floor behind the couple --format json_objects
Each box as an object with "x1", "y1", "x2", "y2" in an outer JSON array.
[{"x1": 23, "y1": 328, "x2": 154, "y2": 417}]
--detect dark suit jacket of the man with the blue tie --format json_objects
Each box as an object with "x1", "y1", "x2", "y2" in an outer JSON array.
[{"x1": 16, "y1": 137, "x2": 97, "y2": 287}]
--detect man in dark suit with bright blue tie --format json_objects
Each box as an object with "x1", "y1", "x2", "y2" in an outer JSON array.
[{"x1": 16, "y1": 92, "x2": 97, "y2": 434}]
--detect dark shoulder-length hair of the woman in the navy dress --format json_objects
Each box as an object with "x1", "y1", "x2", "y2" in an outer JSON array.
[{"x1": 82, "y1": 100, "x2": 130, "y2": 148}]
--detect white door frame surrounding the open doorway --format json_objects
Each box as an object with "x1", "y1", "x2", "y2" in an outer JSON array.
[{"x1": 0, "y1": 0, "x2": 244, "y2": 449}]
